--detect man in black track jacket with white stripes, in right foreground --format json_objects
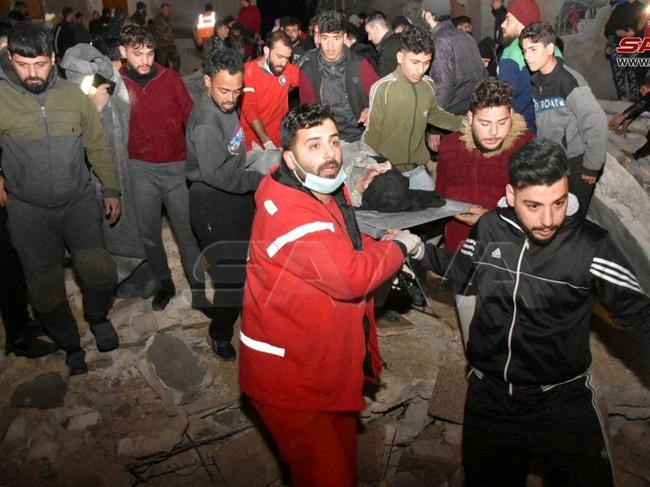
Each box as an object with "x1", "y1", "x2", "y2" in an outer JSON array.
[{"x1": 404, "y1": 139, "x2": 650, "y2": 486}]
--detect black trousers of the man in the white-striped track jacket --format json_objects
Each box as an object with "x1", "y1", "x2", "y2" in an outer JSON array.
[{"x1": 463, "y1": 370, "x2": 614, "y2": 487}]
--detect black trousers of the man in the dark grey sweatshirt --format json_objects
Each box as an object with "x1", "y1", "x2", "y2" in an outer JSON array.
[{"x1": 190, "y1": 183, "x2": 255, "y2": 341}]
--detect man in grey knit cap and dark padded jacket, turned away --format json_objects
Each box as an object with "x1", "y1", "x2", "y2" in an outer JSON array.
[{"x1": 422, "y1": 0, "x2": 487, "y2": 115}]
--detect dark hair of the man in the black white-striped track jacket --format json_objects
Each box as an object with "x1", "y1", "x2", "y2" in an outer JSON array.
[{"x1": 508, "y1": 139, "x2": 569, "y2": 188}]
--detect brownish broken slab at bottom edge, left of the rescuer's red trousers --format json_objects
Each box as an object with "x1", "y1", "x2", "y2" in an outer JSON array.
[{"x1": 213, "y1": 429, "x2": 282, "y2": 487}]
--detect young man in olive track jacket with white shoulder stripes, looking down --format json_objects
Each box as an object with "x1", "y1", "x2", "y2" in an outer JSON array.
[{"x1": 361, "y1": 26, "x2": 463, "y2": 190}]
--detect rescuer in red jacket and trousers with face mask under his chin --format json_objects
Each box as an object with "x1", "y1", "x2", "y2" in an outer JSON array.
[{"x1": 239, "y1": 105, "x2": 421, "y2": 487}]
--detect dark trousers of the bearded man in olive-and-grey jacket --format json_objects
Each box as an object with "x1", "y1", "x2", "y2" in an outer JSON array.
[{"x1": 7, "y1": 184, "x2": 117, "y2": 352}]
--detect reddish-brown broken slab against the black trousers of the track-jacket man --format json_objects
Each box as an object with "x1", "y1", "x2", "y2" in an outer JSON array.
[{"x1": 429, "y1": 365, "x2": 467, "y2": 424}]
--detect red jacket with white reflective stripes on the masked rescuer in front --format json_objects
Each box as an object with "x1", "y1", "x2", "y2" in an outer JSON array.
[{"x1": 239, "y1": 171, "x2": 404, "y2": 411}]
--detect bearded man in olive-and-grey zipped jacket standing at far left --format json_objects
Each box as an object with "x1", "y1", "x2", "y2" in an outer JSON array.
[{"x1": 0, "y1": 24, "x2": 120, "y2": 375}]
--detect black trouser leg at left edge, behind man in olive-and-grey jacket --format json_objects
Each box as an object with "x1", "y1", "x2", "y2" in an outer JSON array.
[{"x1": 0, "y1": 206, "x2": 29, "y2": 343}]
